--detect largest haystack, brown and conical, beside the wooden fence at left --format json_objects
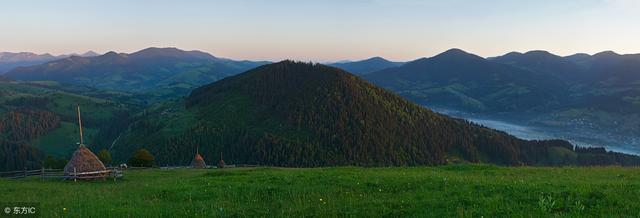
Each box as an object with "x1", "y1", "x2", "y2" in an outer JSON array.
[{"x1": 64, "y1": 144, "x2": 107, "y2": 179}]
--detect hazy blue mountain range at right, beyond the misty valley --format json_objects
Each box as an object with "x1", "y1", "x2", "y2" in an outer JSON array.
[{"x1": 363, "y1": 49, "x2": 640, "y2": 153}]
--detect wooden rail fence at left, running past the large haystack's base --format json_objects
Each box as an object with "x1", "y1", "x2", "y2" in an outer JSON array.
[{"x1": 0, "y1": 168, "x2": 124, "y2": 181}]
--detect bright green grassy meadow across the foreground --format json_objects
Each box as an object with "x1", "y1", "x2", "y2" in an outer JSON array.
[{"x1": 0, "y1": 165, "x2": 640, "y2": 217}]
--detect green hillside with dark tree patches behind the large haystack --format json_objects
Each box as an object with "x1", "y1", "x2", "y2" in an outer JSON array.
[{"x1": 0, "y1": 81, "x2": 138, "y2": 170}]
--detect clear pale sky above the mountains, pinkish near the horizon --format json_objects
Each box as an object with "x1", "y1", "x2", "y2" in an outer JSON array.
[{"x1": 0, "y1": 0, "x2": 640, "y2": 61}]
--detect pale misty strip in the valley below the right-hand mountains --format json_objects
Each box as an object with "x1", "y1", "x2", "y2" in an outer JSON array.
[{"x1": 429, "y1": 107, "x2": 640, "y2": 154}]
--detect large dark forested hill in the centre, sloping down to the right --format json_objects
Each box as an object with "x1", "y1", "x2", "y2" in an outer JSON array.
[{"x1": 115, "y1": 61, "x2": 640, "y2": 167}]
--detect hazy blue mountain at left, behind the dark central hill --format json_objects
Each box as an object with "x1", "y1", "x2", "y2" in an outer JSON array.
[{"x1": 6, "y1": 48, "x2": 264, "y2": 95}]
